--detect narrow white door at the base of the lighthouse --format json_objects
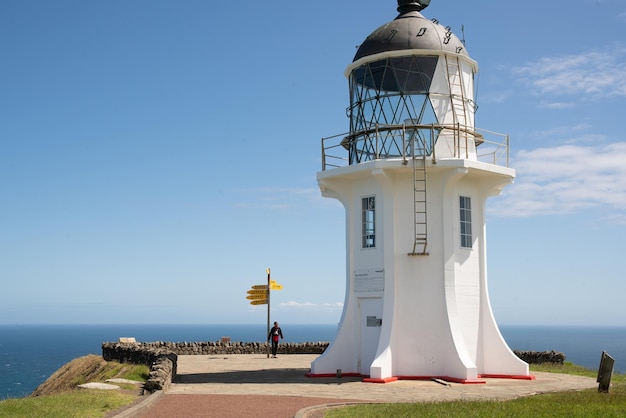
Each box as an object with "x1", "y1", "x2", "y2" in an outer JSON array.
[{"x1": 358, "y1": 298, "x2": 383, "y2": 375}]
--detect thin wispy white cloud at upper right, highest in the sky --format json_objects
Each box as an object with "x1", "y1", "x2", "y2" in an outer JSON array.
[{"x1": 513, "y1": 45, "x2": 626, "y2": 99}]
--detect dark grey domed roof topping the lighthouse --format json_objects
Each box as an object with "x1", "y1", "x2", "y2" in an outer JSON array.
[{"x1": 353, "y1": 0, "x2": 469, "y2": 61}]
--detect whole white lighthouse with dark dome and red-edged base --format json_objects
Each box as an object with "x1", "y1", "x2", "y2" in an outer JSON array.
[{"x1": 311, "y1": 0, "x2": 532, "y2": 383}]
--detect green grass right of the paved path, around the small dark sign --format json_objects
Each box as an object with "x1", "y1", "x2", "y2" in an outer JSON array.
[{"x1": 324, "y1": 363, "x2": 626, "y2": 418}]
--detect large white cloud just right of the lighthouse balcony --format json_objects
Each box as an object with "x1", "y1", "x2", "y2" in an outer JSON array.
[{"x1": 490, "y1": 142, "x2": 626, "y2": 220}]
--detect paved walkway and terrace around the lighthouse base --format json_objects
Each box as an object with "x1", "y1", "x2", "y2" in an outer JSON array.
[{"x1": 114, "y1": 354, "x2": 597, "y2": 417}]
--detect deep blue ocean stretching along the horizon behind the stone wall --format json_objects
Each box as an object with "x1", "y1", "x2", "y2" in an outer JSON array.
[{"x1": 0, "y1": 323, "x2": 626, "y2": 400}]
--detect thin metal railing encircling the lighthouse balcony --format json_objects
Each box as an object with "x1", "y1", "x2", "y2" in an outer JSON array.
[{"x1": 322, "y1": 124, "x2": 509, "y2": 171}]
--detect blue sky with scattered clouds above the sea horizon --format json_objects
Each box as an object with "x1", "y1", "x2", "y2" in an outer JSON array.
[{"x1": 0, "y1": 0, "x2": 626, "y2": 325}]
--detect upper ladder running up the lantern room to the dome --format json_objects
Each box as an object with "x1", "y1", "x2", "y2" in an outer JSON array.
[{"x1": 446, "y1": 55, "x2": 469, "y2": 158}]
